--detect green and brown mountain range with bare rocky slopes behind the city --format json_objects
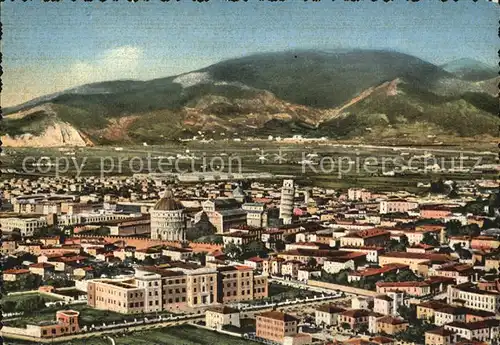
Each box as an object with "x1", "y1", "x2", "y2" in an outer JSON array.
[{"x1": 0, "y1": 50, "x2": 500, "y2": 146}]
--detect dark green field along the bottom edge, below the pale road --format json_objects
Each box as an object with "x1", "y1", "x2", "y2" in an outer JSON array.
[{"x1": 6, "y1": 326, "x2": 257, "y2": 345}]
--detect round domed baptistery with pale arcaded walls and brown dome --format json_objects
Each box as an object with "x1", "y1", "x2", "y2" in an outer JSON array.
[{"x1": 149, "y1": 189, "x2": 187, "y2": 241}]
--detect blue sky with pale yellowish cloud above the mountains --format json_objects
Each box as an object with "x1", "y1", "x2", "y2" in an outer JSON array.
[{"x1": 0, "y1": 0, "x2": 500, "y2": 107}]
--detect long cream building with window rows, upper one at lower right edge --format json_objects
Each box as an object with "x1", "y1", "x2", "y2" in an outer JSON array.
[{"x1": 447, "y1": 283, "x2": 500, "y2": 313}]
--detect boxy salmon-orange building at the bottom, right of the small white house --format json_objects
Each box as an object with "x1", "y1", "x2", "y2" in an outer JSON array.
[{"x1": 256, "y1": 311, "x2": 298, "y2": 344}]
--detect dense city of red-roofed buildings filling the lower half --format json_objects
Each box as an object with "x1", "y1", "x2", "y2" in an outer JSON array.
[{"x1": 0, "y1": 169, "x2": 500, "y2": 345}]
